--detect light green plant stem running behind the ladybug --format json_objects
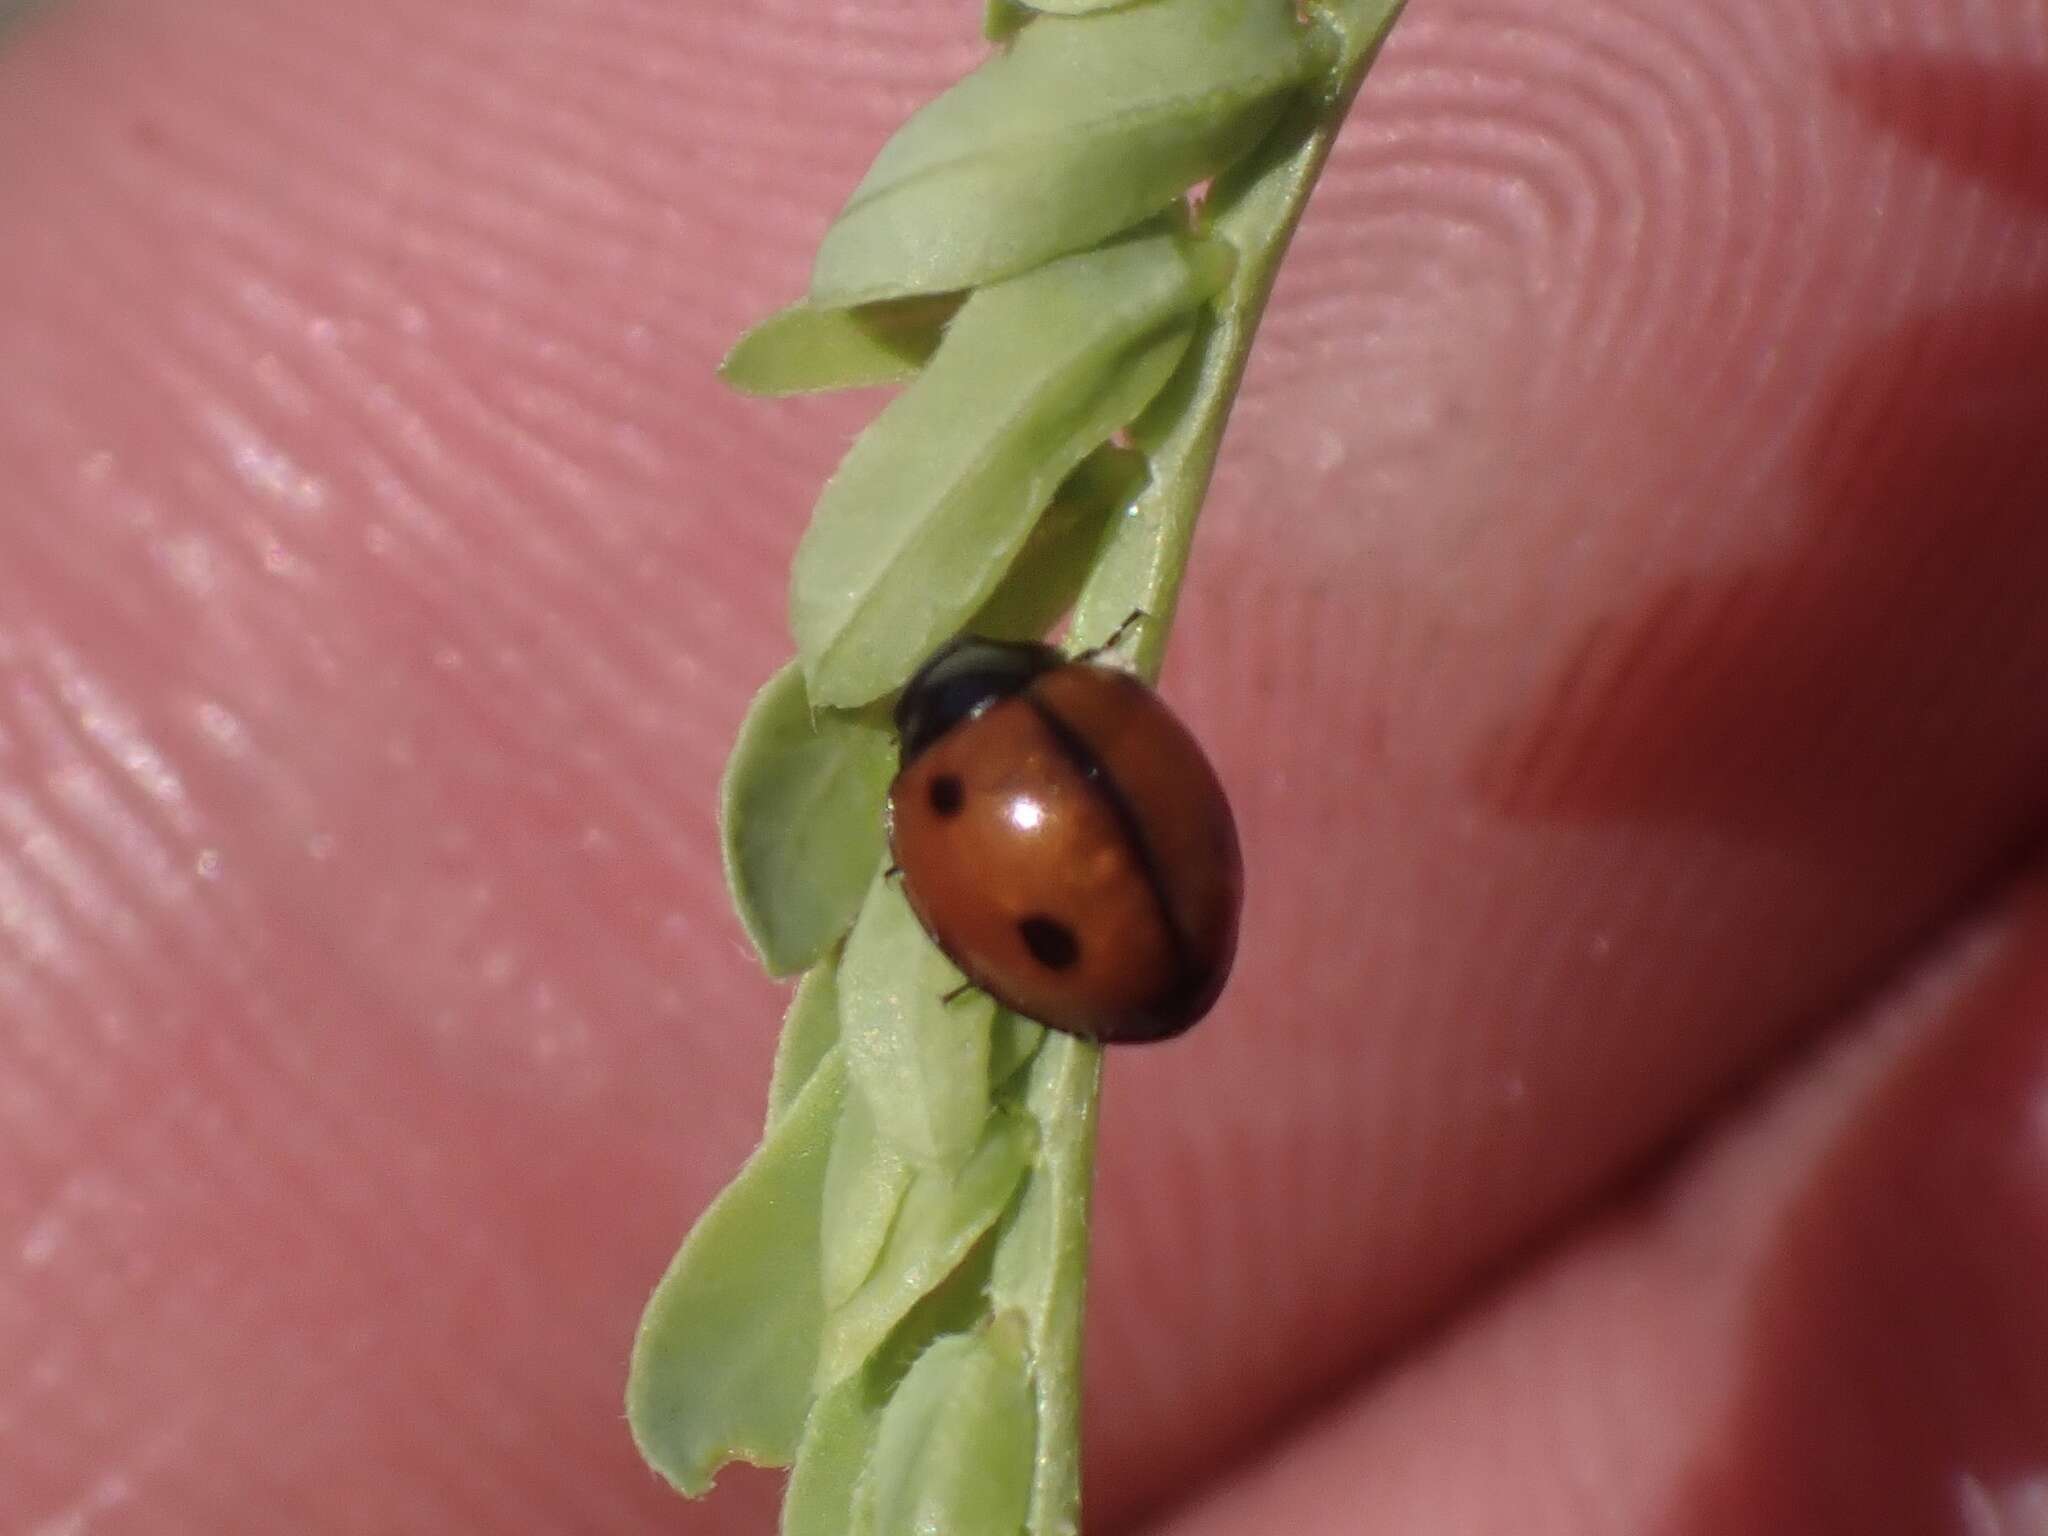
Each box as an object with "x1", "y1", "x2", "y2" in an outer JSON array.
[{"x1": 1032, "y1": 0, "x2": 1401, "y2": 1536}]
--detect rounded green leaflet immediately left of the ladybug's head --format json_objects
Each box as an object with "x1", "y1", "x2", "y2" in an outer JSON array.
[{"x1": 719, "y1": 666, "x2": 895, "y2": 975}]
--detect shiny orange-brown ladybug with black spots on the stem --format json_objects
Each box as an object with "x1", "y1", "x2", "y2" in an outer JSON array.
[{"x1": 889, "y1": 614, "x2": 1243, "y2": 1042}]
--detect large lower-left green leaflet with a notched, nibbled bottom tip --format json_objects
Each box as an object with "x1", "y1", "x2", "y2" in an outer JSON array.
[{"x1": 627, "y1": 1053, "x2": 846, "y2": 1497}]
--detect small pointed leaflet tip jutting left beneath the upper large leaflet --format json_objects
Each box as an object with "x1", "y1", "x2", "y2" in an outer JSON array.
[{"x1": 719, "y1": 295, "x2": 961, "y2": 395}]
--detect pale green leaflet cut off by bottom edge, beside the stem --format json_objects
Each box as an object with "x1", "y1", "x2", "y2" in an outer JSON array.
[{"x1": 856, "y1": 1319, "x2": 1036, "y2": 1536}]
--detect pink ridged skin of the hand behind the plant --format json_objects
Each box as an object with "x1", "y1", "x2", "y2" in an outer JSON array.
[{"x1": 0, "y1": 0, "x2": 2048, "y2": 1536}]
